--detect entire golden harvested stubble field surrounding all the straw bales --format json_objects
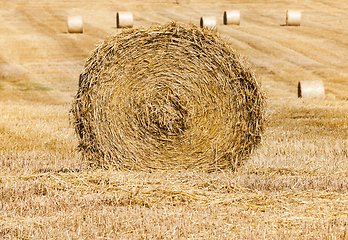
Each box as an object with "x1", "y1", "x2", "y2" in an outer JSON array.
[{"x1": 0, "y1": 0, "x2": 348, "y2": 239}]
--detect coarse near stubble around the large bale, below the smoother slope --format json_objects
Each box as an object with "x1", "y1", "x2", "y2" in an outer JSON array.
[{"x1": 0, "y1": 98, "x2": 348, "y2": 239}]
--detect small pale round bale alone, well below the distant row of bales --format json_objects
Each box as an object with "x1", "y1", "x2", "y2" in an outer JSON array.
[{"x1": 298, "y1": 80, "x2": 325, "y2": 98}]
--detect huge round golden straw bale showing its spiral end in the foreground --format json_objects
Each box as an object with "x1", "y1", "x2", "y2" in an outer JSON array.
[{"x1": 71, "y1": 22, "x2": 264, "y2": 171}]
